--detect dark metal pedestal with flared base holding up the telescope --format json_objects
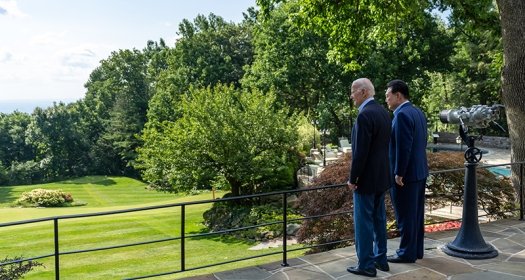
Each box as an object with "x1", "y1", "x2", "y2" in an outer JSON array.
[{"x1": 442, "y1": 128, "x2": 498, "y2": 259}]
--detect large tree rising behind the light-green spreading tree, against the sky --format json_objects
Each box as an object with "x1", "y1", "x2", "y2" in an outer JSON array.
[{"x1": 148, "y1": 14, "x2": 253, "y2": 126}]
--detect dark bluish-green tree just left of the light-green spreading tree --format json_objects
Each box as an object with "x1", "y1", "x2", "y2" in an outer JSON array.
[{"x1": 83, "y1": 47, "x2": 151, "y2": 176}]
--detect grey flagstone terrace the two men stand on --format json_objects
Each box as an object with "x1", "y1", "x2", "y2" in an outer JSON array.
[{"x1": 187, "y1": 219, "x2": 525, "y2": 280}]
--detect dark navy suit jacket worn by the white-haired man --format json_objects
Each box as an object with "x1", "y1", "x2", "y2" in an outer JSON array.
[{"x1": 349, "y1": 100, "x2": 392, "y2": 194}]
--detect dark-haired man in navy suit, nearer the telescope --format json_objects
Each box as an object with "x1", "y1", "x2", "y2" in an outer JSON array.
[{"x1": 386, "y1": 80, "x2": 428, "y2": 263}]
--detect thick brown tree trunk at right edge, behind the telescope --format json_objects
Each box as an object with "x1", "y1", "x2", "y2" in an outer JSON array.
[{"x1": 497, "y1": 0, "x2": 525, "y2": 193}]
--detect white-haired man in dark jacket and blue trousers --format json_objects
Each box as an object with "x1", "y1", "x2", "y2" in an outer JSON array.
[{"x1": 347, "y1": 78, "x2": 392, "y2": 277}]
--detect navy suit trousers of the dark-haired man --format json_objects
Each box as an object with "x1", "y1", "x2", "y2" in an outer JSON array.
[{"x1": 390, "y1": 180, "x2": 426, "y2": 261}]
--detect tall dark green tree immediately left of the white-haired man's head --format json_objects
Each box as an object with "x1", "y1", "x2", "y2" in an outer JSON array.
[{"x1": 242, "y1": 1, "x2": 351, "y2": 136}]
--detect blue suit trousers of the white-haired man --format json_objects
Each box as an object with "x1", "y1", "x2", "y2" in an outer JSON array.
[{"x1": 354, "y1": 192, "x2": 387, "y2": 269}]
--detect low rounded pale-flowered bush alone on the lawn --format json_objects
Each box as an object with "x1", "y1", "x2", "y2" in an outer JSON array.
[{"x1": 15, "y1": 189, "x2": 73, "y2": 207}]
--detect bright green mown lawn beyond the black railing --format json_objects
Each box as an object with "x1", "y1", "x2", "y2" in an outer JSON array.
[{"x1": 0, "y1": 176, "x2": 300, "y2": 279}]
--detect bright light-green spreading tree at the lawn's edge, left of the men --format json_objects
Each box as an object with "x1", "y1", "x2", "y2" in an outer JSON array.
[{"x1": 136, "y1": 85, "x2": 297, "y2": 196}]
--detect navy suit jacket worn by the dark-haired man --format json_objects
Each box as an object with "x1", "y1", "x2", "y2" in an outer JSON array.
[{"x1": 390, "y1": 102, "x2": 428, "y2": 183}]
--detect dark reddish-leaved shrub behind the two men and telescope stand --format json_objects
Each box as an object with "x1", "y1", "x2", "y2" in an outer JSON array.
[{"x1": 297, "y1": 152, "x2": 515, "y2": 253}]
